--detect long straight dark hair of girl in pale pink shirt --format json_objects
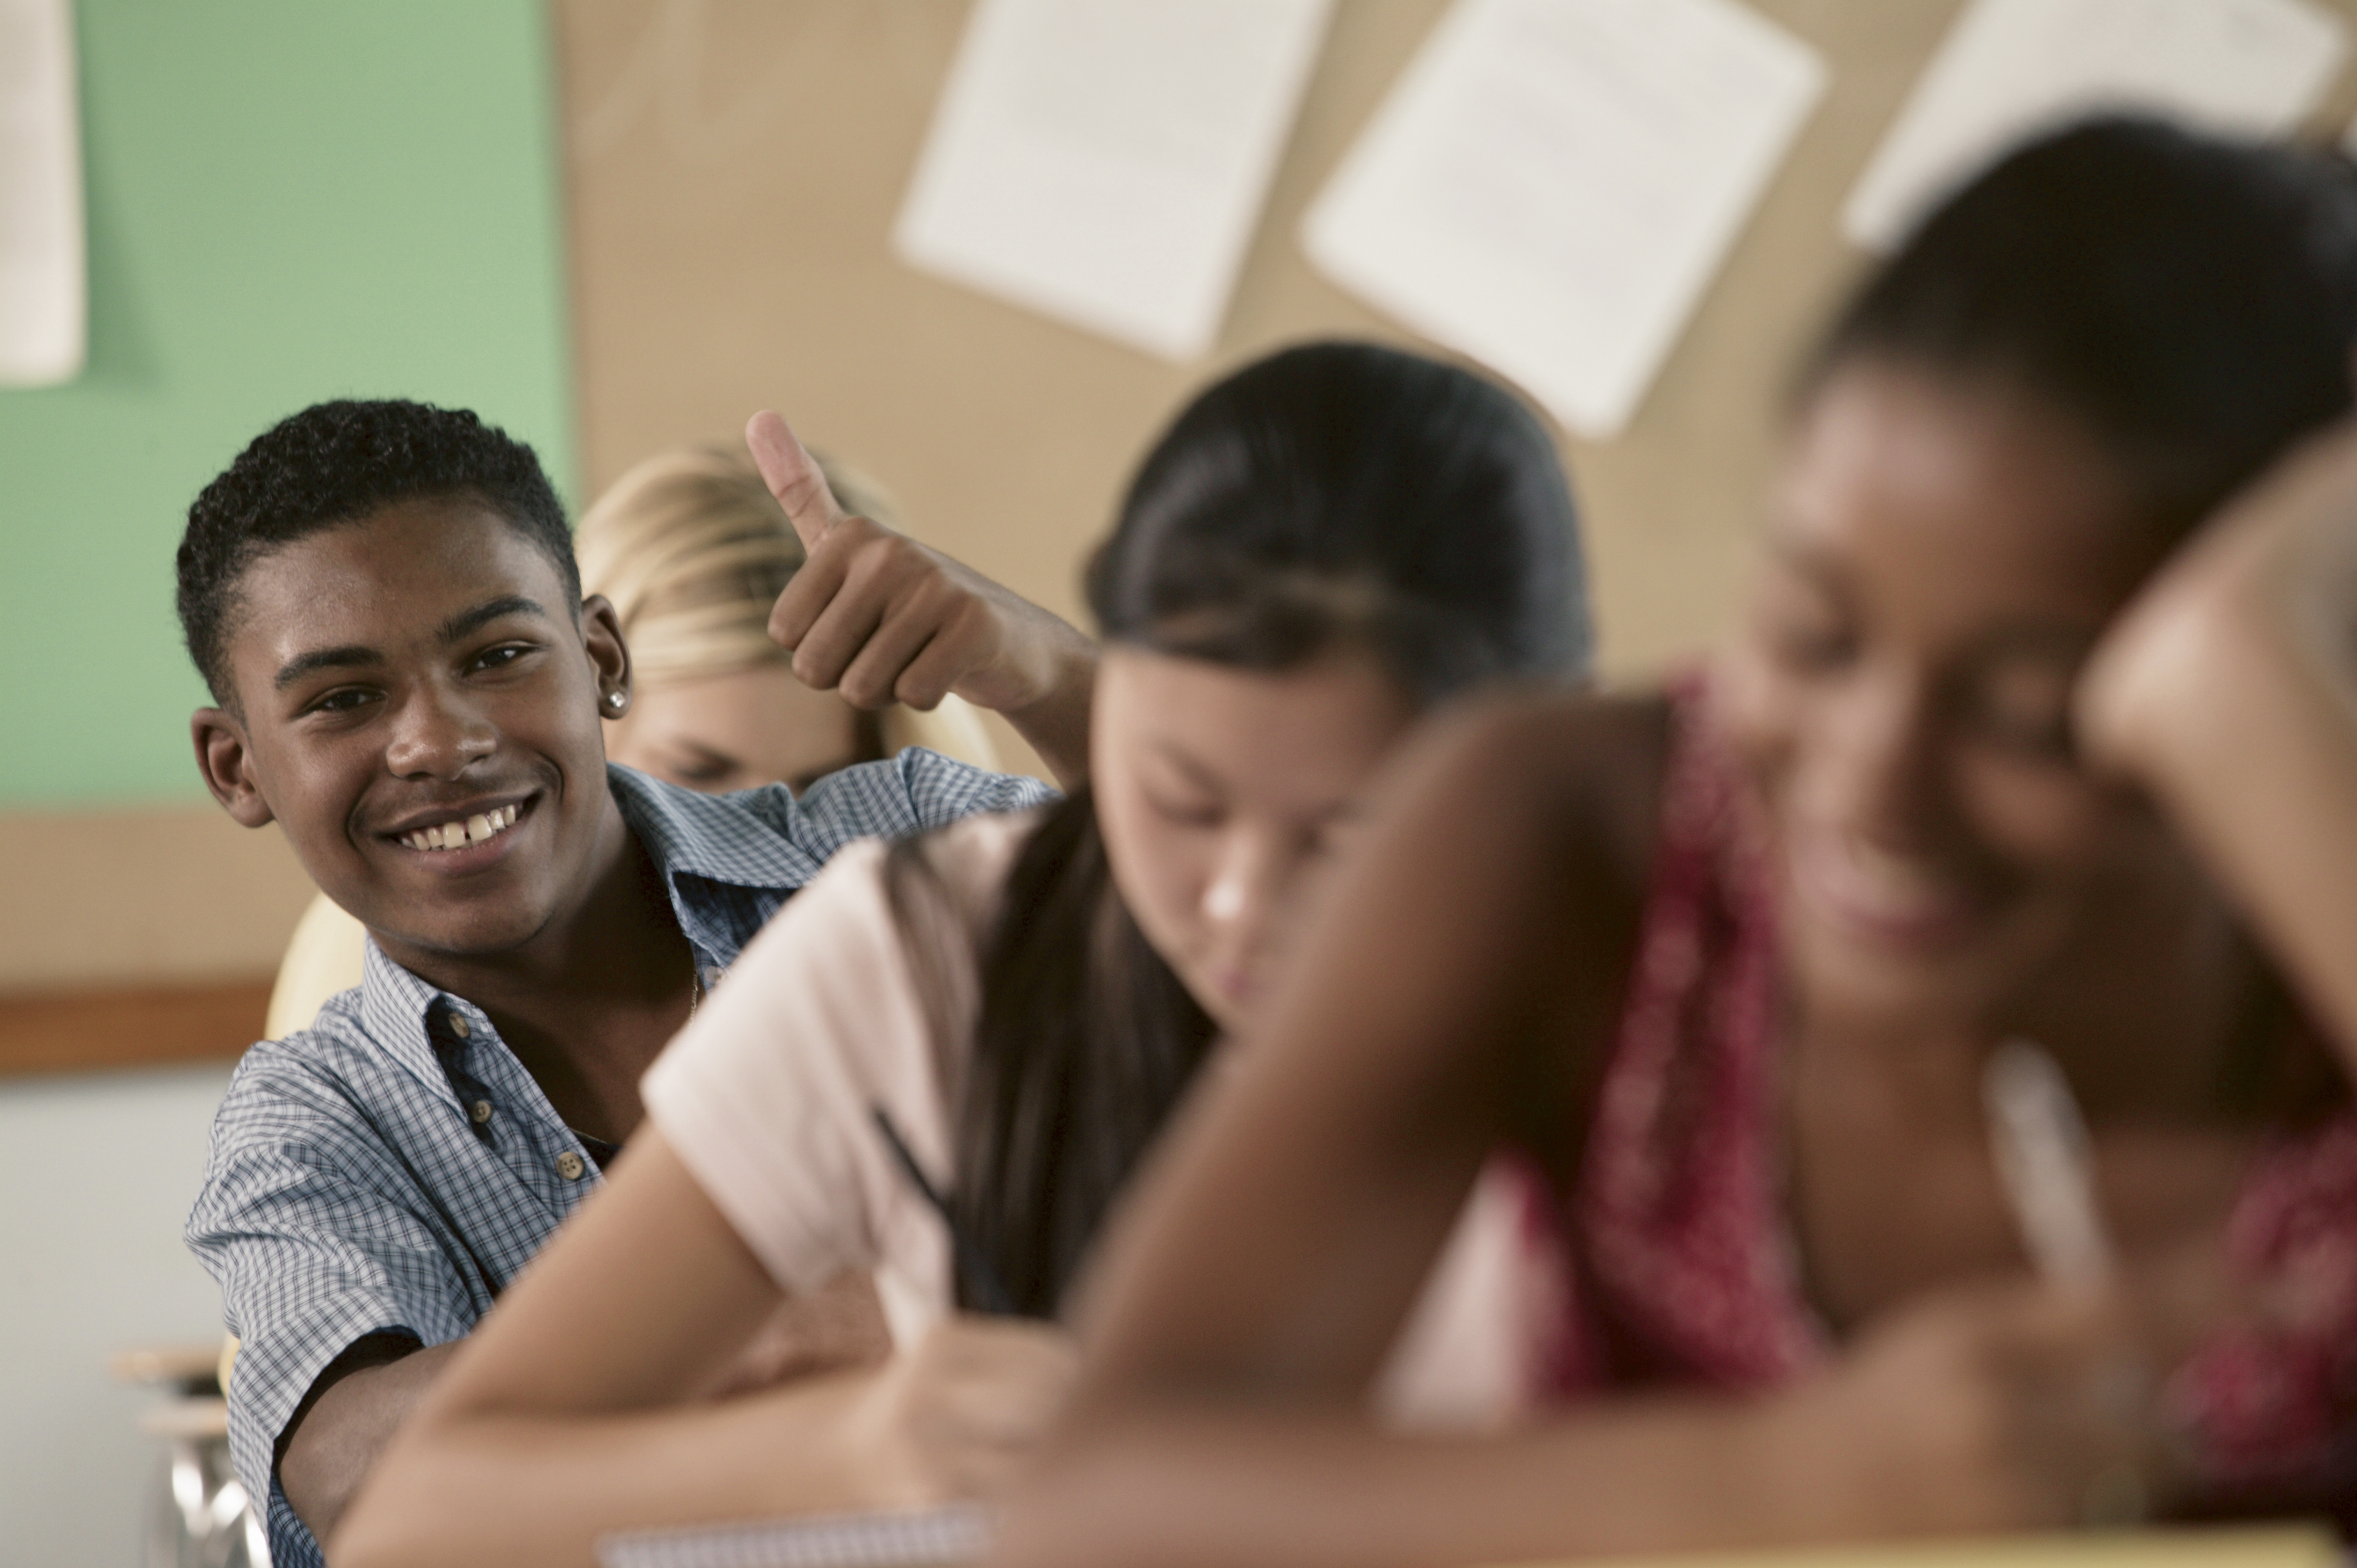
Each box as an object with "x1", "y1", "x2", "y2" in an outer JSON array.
[{"x1": 933, "y1": 344, "x2": 1588, "y2": 1318}]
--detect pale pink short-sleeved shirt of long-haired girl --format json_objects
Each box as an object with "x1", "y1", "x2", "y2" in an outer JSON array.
[{"x1": 641, "y1": 816, "x2": 1560, "y2": 1429}]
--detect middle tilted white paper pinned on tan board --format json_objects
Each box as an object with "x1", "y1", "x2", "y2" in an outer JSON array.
[{"x1": 1301, "y1": 0, "x2": 1824, "y2": 436}]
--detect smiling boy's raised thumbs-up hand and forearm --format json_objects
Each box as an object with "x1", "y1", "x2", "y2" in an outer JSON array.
[{"x1": 745, "y1": 410, "x2": 1096, "y2": 776}]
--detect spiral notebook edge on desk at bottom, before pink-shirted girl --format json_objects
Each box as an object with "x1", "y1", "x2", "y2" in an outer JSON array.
[{"x1": 596, "y1": 1504, "x2": 990, "y2": 1568}]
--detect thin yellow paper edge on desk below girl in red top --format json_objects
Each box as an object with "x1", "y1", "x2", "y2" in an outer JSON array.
[{"x1": 1516, "y1": 1526, "x2": 2350, "y2": 1568}]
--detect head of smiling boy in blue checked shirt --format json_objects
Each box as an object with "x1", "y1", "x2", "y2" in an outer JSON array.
[{"x1": 179, "y1": 401, "x2": 629, "y2": 955}]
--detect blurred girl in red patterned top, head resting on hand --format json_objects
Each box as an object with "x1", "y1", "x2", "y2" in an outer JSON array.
[{"x1": 1002, "y1": 120, "x2": 2357, "y2": 1568}]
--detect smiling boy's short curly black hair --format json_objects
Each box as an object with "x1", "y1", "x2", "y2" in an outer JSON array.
[{"x1": 179, "y1": 399, "x2": 582, "y2": 703}]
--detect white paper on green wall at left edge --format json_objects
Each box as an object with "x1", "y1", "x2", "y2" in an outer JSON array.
[{"x1": 0, "y1": 0, "x2": 90, "y2": 387}]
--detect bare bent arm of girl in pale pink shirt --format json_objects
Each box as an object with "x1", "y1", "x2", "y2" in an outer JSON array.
[{"x1": 330, "y1": 1125, "x2": 1070, "y2": 1568}]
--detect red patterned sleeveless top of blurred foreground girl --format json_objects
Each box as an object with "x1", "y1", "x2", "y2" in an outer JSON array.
[{"x1": 1551, "y1": 682, "x2": 2357, "y2": 1486}]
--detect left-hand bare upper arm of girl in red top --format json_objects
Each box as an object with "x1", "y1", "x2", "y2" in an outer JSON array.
[{"x1": 1080, "y1": 698, "x2": 1659, "y2": 1405}]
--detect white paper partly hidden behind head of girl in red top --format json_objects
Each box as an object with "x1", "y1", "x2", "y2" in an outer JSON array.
[{"x1": 1841, "y1": 0, "x2": 2347, "y2": 250}]
